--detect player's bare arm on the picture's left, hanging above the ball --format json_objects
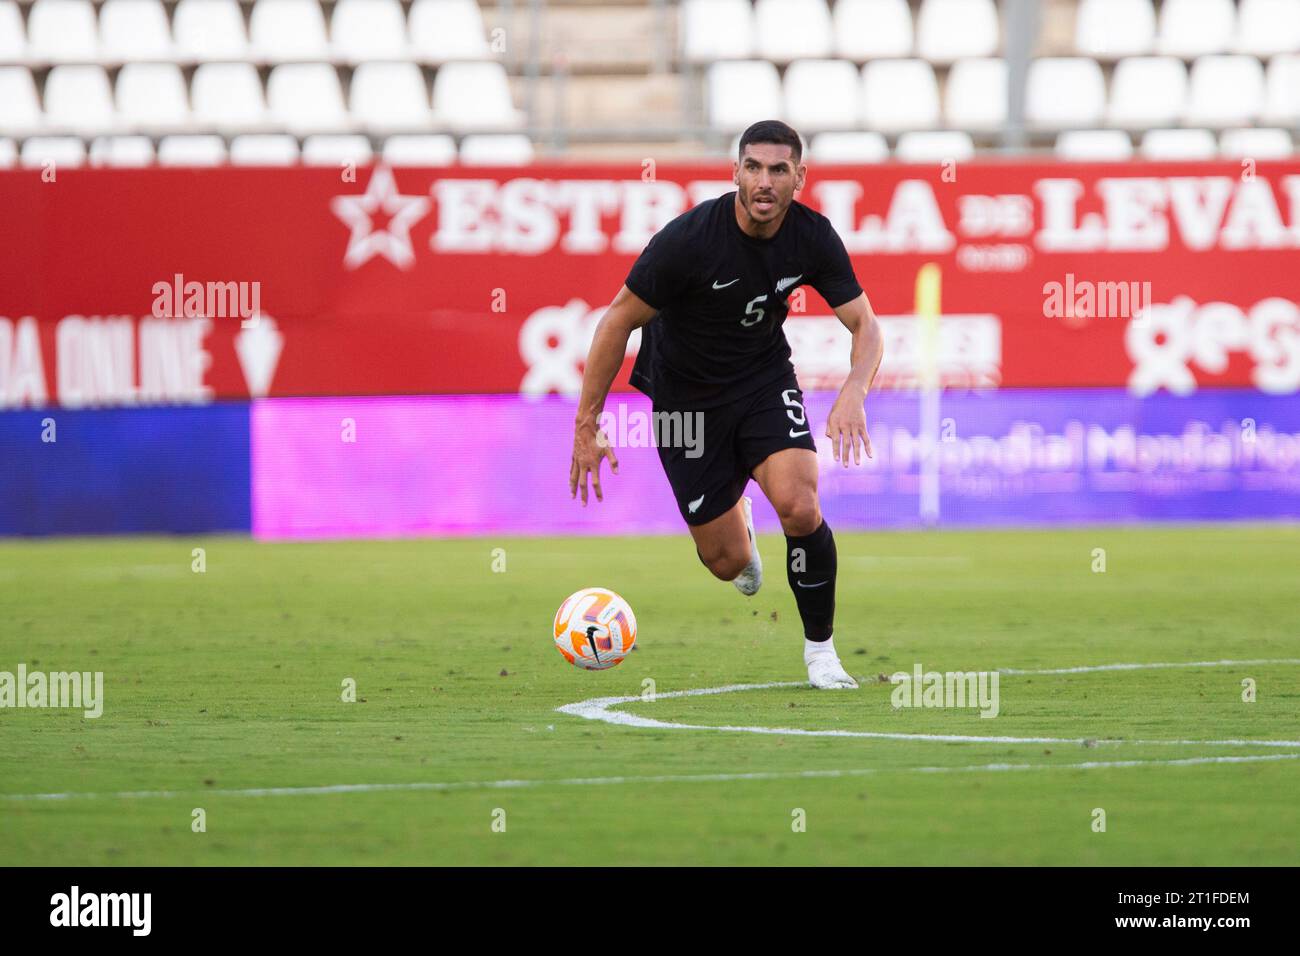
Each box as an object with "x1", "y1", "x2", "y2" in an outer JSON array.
[{"x1": 569, "y1": 286, "x2": 658, "y2": 506}]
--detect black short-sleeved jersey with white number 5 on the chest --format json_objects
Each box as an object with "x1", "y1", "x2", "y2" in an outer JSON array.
[{"x1": 627, "y1": 193, "x2": 862, "y2": 408}]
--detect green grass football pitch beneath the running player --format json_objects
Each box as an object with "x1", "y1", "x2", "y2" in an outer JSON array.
[{"x1": 0, "y1": 525, "x2": 1300, "y2": 865}]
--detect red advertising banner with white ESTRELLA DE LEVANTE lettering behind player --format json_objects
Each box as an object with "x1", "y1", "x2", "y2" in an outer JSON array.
[{"x1": 0, "y1": 161, "x2": 1300, "y2": 407}]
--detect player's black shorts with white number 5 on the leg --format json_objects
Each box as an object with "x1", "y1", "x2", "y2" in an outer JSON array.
[{"x1": 654, "y1": 375, "x2": 816, "y2": 524}]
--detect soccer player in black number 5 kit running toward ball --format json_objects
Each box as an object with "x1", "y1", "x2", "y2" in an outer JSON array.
[{"x1": 569, "y1": 120, "x2": 883, "y2": 689}]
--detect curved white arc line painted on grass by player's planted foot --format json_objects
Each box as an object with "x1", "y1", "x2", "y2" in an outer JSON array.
[{"x1": 555, "y1": 658, "x2": 1300, "y2": 748}]
